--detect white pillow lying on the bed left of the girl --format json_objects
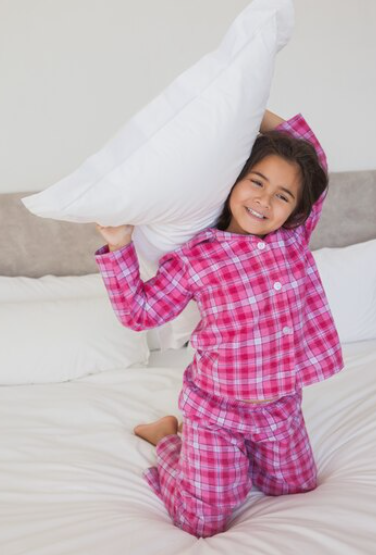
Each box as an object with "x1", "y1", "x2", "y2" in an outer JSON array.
[{"x1": 0, "y1": 274, "x2": 149, "y2": 384}]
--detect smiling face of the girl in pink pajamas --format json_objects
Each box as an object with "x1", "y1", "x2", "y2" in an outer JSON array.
[{"x1": 226, "y1": 154, "x2": 301, "y2": 237}]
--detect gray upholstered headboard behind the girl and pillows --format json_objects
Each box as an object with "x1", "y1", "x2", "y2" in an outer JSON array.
[{"x1": 0, "y1": 170, "x2": 376, "y2": 277}]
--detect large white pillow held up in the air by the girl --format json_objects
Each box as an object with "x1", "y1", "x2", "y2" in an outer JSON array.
[{"x1": 22, "y1": 0, "x2": 294, "y2": 268}]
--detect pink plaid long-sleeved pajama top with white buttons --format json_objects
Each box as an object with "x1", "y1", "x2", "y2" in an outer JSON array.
[{"x1": 95, "y1": 114, "x2": 343, "y2": 400}]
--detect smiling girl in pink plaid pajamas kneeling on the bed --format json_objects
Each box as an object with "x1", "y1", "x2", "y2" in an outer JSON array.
[{"x1": 95, "y1": 111, "x2": 343, "y2": 537}]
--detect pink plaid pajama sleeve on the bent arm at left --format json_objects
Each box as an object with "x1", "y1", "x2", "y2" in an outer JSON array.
[{"x1": 95, "y1": 242, "x2": 193, "y2": 331}]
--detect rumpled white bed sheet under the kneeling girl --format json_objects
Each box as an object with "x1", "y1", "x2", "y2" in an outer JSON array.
[{"x1": 0, "y1": 341, "x2": 376, "y2": 555}]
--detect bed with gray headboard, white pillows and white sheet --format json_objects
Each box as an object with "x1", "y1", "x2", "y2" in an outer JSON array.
[{"x1": 0, "y1": 171, "x2": 376, "y2": 555}]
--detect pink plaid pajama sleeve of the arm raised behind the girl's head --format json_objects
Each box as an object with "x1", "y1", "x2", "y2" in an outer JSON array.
[{"x1": 276, "y1": 114, "x2": 328, "y2": 243}]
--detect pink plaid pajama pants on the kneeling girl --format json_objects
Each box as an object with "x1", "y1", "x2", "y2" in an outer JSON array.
[{"x1": 144, "y1": 372, "x2": 317, "y2": 537}]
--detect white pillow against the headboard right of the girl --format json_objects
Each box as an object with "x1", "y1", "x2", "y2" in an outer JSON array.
[{"x1": 312, "y1": 239, "x2": 376, "y2": 343}]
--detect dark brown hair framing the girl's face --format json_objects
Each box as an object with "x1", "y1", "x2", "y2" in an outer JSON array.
[{"x1": 215, "y1": 131, "x2": 329, "y2": 231}]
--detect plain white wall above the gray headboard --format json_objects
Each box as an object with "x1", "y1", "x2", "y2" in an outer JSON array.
[{"x1": 0, "y1": 0, "x2": 376, "y2": 192}]
